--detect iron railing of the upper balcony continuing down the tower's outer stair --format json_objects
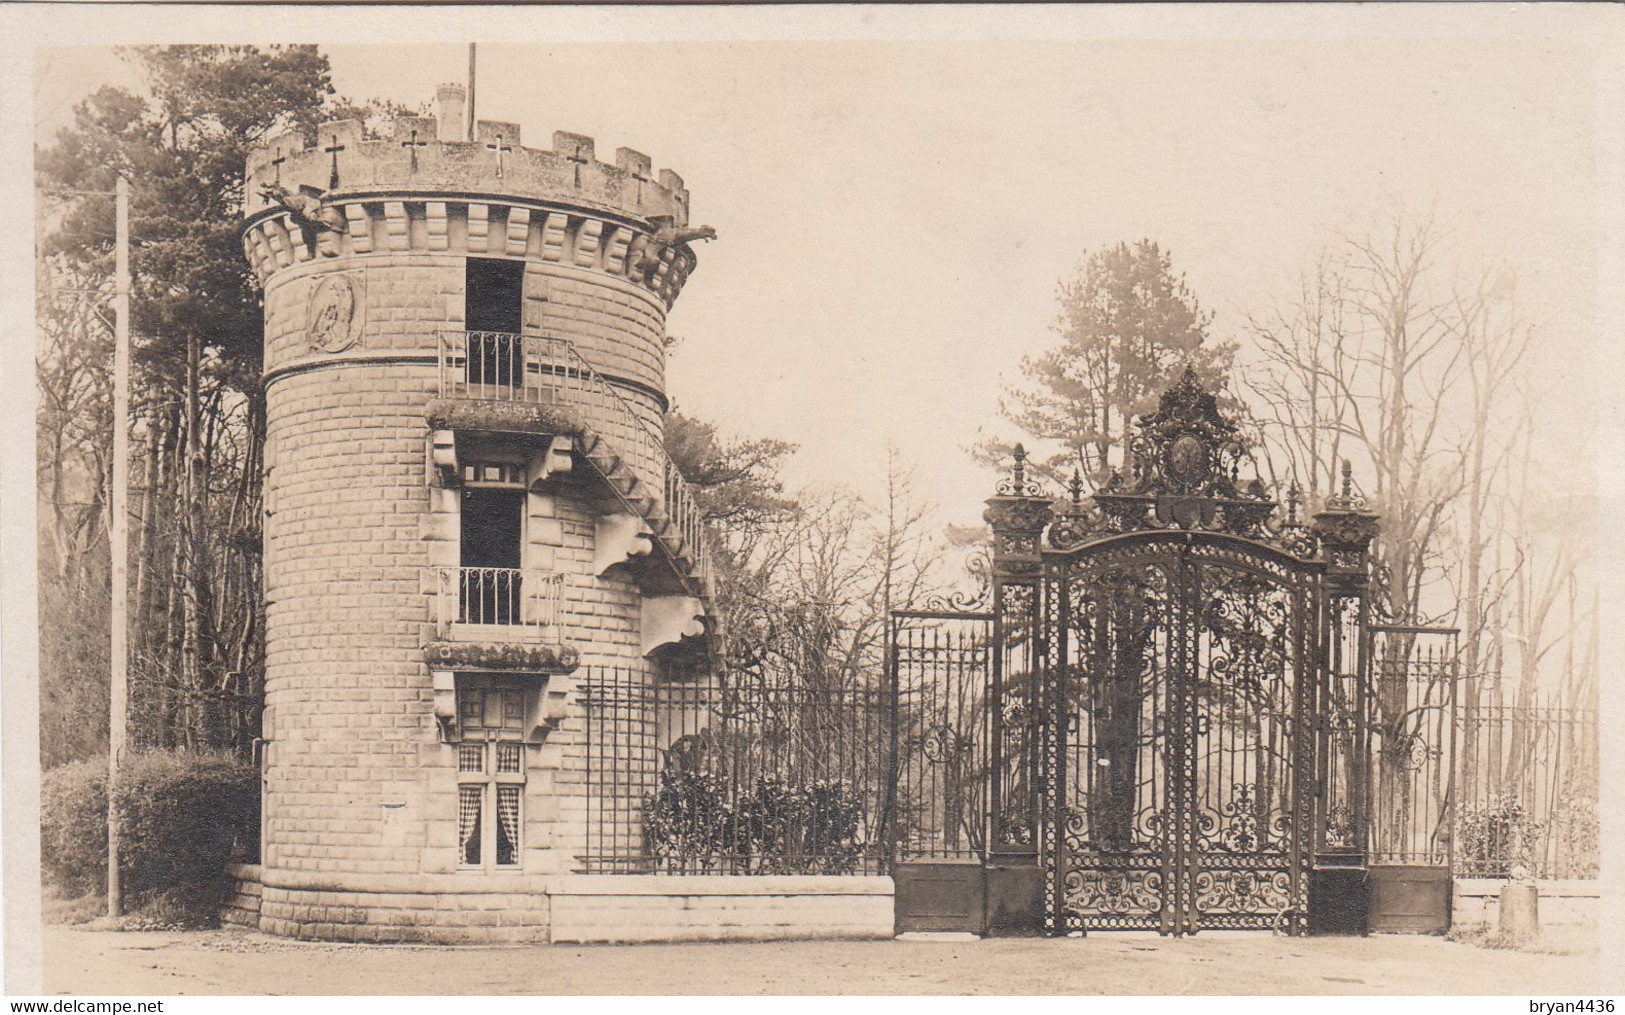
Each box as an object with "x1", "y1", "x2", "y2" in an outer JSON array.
[{"x1": 439, "y1": 331, "x2": 710, "y2": 581}]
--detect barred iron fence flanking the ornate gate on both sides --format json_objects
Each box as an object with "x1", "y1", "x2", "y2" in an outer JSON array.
[{"x1": 580, "y1": 633, "x2": 1599, "y2": 879}]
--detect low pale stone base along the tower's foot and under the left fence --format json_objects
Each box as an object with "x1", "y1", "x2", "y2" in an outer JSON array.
[{"x1": 221, "y1": 864, "x2": 894, "y2": 944}]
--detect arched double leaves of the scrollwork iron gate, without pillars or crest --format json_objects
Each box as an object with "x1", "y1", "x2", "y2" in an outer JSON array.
[{"x1": 1043, "y1": 533, "x2": 1320, "y2": 934}]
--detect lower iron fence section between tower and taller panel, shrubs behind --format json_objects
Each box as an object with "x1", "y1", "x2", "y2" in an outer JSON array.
[{"x1": 580, "y1": 669, "x2": 892, "y2": 874}]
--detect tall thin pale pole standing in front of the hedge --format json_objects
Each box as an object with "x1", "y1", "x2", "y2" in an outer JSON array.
[{"x1": 107, "y1": 175, "x2": 130, "y2": 916}]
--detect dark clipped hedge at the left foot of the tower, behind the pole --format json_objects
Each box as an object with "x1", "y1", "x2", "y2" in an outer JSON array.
[{"x1": 41, "y1": 752, "x2": 260, "y2": 922}]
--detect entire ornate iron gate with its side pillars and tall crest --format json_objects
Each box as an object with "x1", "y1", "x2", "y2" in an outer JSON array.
[{"x1": 962, "y1": 372, "x2": 1376, "y2": 934}]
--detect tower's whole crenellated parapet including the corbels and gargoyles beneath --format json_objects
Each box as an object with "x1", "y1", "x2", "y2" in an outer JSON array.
[{"x1": 244, "y1": 117, "x2": 713, "y2": 307}]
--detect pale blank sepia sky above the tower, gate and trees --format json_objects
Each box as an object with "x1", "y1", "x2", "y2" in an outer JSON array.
[{"x1": 22, "y1": 8, "x2": 1601, "y2": 525}]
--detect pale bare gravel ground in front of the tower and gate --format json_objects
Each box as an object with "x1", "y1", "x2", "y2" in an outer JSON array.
[{"x1": 42, "y1": 927, "x2": 1612, "y2": 996}]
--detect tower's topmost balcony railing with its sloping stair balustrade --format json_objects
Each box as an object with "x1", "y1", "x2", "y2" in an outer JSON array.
[{"x1": 439, "y1": 331, "x2": 710, "y2": 588}]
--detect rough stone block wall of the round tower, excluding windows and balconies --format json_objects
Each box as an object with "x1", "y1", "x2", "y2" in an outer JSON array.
[{"x1": 244, "y1": 110, "x2": 694, "y2": 940}]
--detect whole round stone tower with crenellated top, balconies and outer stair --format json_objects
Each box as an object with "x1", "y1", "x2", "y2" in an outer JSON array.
[{"x1": 242, "y1": 86, "x2": 712, "y2": 940}]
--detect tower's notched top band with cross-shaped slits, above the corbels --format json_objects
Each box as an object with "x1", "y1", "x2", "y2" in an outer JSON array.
[{"x1": 244, "y1": 114, "x2": 689, "y2": 227}]
